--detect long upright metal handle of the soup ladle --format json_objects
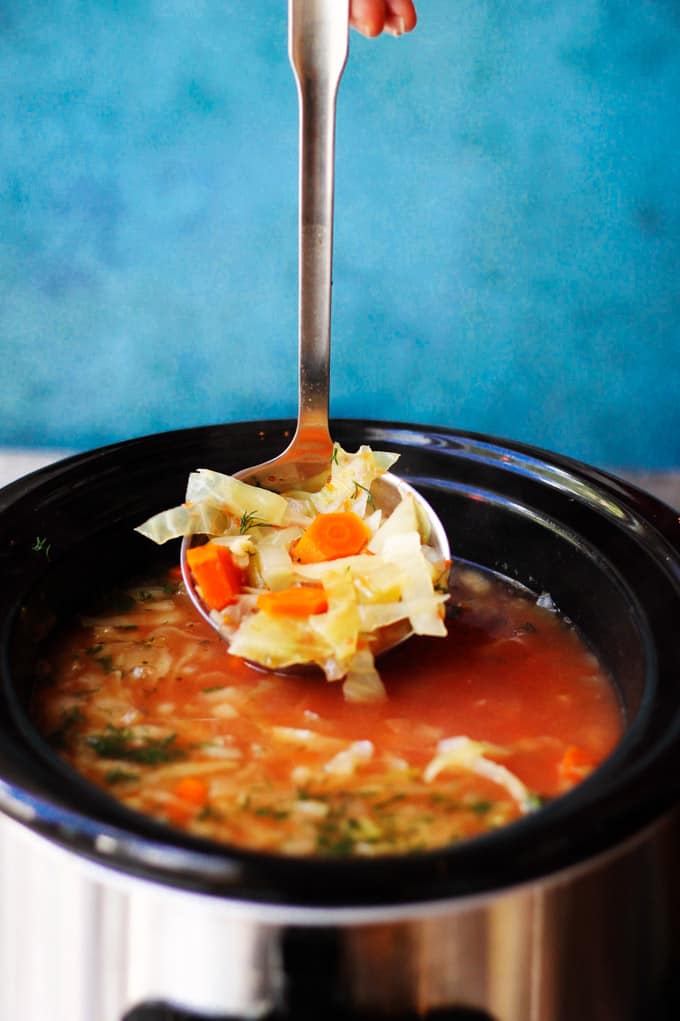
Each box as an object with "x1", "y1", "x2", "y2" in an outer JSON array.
[{"x1": 288, "y1": 0, "x2": 349, "y2": 441}]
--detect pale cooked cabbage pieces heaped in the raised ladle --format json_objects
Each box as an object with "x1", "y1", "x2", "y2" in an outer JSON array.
[{"x1": 137, "y1": 444, "x2": 448, "y2": 701}]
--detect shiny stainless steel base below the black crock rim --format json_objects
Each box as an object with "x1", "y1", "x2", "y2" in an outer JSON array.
[{"x1": 0, "y1": 804, "x2": 678, "y2": 1021}]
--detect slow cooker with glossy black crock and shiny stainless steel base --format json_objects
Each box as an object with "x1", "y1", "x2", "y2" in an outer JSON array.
[{"x1": 0, "y1": 421, "x2": 680, "y2": 1021}]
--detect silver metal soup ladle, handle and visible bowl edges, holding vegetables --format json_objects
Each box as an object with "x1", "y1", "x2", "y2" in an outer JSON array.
[{"x1": 182, "y1": 0, "x2": 450, "y2": 652}]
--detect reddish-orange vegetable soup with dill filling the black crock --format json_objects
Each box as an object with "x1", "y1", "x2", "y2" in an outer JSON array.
[{"x1": 33, "y1": 567, "x2": 623, "y2": 856}]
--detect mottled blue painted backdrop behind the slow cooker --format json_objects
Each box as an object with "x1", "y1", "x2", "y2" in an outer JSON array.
[{"x1": 0, "y1": 0, "x2": 680, "y2": 467}]
